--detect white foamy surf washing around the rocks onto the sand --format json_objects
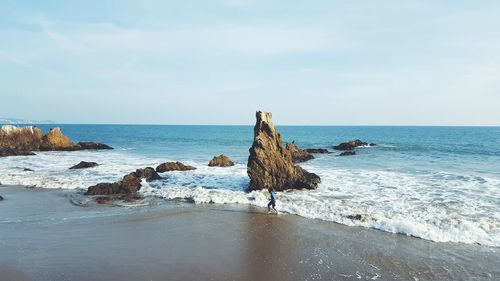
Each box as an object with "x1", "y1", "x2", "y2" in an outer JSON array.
[{"x1": 0, "y1": 151, "x2": 500, "y2": 247}]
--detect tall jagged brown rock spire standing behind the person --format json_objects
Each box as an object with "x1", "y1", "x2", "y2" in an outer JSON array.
[{"x1": 247, "y1": 111, "x2": 321, "y2": 191}]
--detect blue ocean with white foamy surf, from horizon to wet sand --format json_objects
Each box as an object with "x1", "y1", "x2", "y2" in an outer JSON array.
[{"x1": 0, "y1": 124, "x2": 500, "y2": 247}]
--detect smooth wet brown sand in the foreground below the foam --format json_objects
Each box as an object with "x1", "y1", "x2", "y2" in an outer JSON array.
[{"x1": 0, "y1": 186, "x2": 500, "y2": 281}]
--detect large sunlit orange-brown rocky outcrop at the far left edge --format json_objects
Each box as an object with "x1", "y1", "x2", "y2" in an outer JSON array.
[{"x1": 0, "y1": 125, "x2": 112, "y2": 157}]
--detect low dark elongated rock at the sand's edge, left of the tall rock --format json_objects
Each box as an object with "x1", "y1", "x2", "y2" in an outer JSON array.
[{"x1": 85, "y1": 167, "x2": 161, "y2": 195}]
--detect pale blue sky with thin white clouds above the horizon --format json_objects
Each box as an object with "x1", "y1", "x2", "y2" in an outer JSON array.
[{"x1": 0, "y1": 0, "x2": 500, "y2": 125}]
